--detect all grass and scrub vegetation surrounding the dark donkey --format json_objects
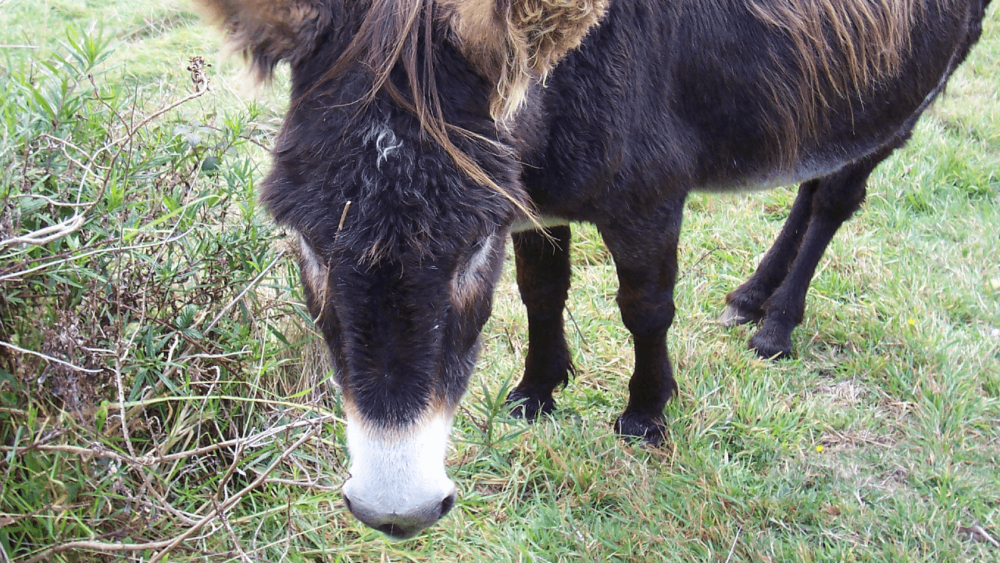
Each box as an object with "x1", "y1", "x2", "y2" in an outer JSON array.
[{"x1": 0, "y1": 0, "x2": 1000, "y2": 562}]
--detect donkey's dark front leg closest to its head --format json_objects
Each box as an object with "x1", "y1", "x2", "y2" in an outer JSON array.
[{"x1": 507, "y1": 226, "x2": 573, "y2": 420}]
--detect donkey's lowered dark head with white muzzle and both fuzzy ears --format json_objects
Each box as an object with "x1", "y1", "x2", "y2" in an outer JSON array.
[{"x1": 195, "y1": 0, "x2": 606, "y2": 537}]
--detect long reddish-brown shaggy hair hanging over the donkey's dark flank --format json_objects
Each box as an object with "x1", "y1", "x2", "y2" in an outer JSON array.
[{"x1": 746, "y1": 0, "x2": 923, "y2": 160}]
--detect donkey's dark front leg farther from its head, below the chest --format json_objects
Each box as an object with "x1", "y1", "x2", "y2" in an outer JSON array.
[{"x1": 603, "y1": 198, "x2": 684, "y2": 446}]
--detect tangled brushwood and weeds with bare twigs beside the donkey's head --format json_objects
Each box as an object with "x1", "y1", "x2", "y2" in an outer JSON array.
[{"x1": 0, "y1": 27, "x2": 335, "y2": 561}]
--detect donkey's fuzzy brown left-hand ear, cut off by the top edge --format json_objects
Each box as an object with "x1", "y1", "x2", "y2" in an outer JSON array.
[{"x1": 196, "y1": 0, "x2": 331, "y2": 81}]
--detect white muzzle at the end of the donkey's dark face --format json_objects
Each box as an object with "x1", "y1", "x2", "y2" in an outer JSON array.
[{"x1": 343, "y1": 412, "x2": 455, "y2": 527}]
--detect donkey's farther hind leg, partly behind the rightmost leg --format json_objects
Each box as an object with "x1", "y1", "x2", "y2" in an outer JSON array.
[{"x1": 719, "y1": 180, "x2": 819, "y2": 327}]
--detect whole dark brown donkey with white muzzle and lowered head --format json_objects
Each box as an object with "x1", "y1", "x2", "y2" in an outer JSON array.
[{"x1": 201, "y1": 0, "x2": 989, "y2": 537}]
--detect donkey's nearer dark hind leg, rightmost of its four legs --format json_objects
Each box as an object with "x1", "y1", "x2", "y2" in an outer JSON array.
[{"x1": 750, "y1": 149, "x2": 892, "y2": 358}]
